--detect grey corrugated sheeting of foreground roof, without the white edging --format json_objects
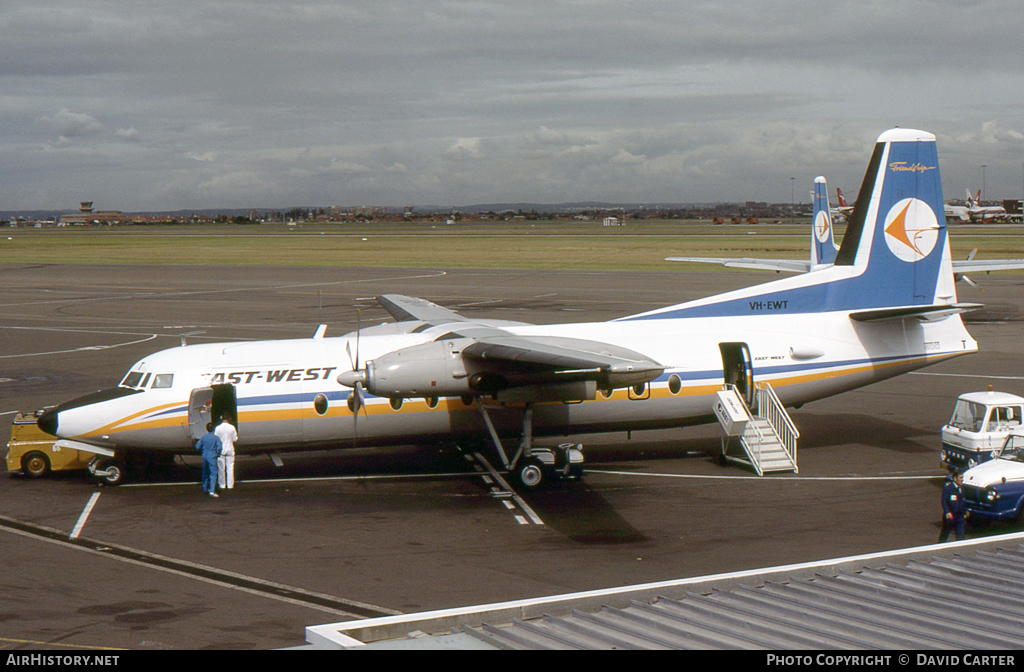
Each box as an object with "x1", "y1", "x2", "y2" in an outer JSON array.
[{"x1": 462, "y1": 546, "x2": 1024, "y2": 649}]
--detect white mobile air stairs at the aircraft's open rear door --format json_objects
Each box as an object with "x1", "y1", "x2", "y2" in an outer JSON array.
[{"x1": 714, "y1": 382, "x2": 800, "y2": 476}]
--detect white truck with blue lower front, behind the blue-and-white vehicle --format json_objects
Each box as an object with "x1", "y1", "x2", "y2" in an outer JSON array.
[{"x1": 939, "y1": 390, "x2": 1024, "y2": 471}]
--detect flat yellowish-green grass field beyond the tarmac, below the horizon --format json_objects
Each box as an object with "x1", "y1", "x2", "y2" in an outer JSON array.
[{"x1": 0, "y1": 220, "x2": 1024, "y2": 272}]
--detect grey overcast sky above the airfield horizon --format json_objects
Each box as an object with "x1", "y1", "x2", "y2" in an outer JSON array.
[{"x1": 0, "y1": 0, "x2": 1024, "y2": 211}]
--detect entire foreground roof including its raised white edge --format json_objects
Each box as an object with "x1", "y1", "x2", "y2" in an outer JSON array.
[{"x1": 306, "y1": 533, "x2": 1024, "y2": 649}]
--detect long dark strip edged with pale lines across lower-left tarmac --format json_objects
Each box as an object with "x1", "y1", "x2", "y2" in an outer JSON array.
[{"x1": 0, "y1": 515, "x2": 401, "y2": 618}]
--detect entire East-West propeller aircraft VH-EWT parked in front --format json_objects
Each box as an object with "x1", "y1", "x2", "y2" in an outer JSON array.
[{"x1": 39, "y1": 129, "x2": 978, "y2": 486}]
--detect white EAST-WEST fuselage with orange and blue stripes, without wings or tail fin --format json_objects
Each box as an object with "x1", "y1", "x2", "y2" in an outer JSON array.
[{"x1": 48, "y1": 312, "x2": 977, "y2": 453}]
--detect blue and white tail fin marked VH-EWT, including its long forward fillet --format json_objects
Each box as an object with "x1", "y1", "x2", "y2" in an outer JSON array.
[{"x1": 623, "y1": 128, "x2": 973, "y2": 322}]
